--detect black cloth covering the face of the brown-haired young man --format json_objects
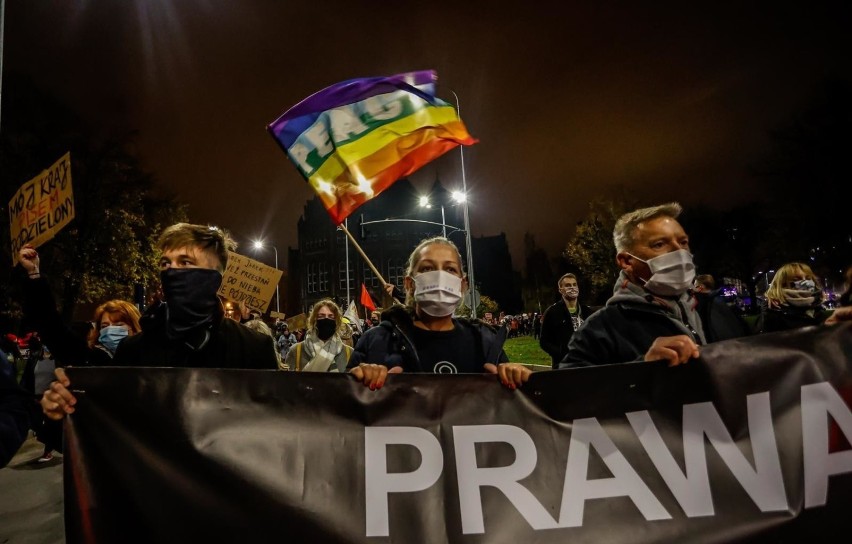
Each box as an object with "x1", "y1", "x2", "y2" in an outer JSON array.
[{"x1": 160, "y1": 268, "x2": 222, "y2": 338}]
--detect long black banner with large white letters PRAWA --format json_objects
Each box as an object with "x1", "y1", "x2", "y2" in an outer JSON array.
[{"x1": 65, "y1": 324, "x2": 852, "y2": 544}]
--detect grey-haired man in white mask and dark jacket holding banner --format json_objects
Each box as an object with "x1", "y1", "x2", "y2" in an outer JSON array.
[{"x1": 559, "y1": 202, "x2": 744, "y2": 368}]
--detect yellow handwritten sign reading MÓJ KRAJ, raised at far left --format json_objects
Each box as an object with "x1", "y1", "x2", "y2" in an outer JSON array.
[{"x1": 9, "y1": 151, "x2": 75, "y2": 266}]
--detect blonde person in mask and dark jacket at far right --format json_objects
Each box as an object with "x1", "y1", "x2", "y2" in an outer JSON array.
[{"x1": 756, "y1": 262, "x2": 831, "y2": 333}]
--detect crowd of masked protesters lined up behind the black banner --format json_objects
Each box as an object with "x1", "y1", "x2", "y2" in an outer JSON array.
[{"x1": 0, "y1": 202, "x2": 852, "y2": 464}]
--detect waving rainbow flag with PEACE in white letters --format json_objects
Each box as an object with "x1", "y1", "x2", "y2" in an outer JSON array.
[{"x1": 267, "y1": 70, "x2": 478, "y2": 225}]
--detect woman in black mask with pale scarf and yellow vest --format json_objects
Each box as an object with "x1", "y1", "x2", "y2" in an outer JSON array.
[{"x1": 286, "y1": 299, "x2": 352, "y2": 372}]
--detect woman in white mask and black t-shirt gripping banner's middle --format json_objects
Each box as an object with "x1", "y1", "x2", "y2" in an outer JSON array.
[{"x1": 349, "y1": 237, "x2": 531, "y2": 389}]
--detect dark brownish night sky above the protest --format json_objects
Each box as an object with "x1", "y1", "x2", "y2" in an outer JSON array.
[{"x1": 3, "y1": 0, "x2": 852, "y2": 268}]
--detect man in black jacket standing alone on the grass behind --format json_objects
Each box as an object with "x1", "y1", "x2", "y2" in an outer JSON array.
[{"x1": 539, "y1": 272, "x2": 592, "y2": 369}]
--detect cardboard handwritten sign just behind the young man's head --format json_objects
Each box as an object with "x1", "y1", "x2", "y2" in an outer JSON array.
[{"x1": 219, "y1": 251, "x2": 283, "y2": 313}]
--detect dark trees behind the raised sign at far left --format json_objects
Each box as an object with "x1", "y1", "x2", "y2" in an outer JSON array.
[{"x1": 0, "y1": 77, "x2": 186, "y2": 332}]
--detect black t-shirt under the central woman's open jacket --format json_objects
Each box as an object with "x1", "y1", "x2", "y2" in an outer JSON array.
[{"x1": 411, "y1": 324, "x2": 484, "y2": 374}]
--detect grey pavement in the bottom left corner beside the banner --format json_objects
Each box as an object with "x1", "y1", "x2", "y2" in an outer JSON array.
[{"x1": 0, "y1": 431, "x2": 65, "y2": 544}]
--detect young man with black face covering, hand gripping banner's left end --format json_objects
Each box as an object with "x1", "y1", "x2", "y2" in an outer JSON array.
[{"x1": 41, "y1": 223, "x2": 278, "y2": 419}]
